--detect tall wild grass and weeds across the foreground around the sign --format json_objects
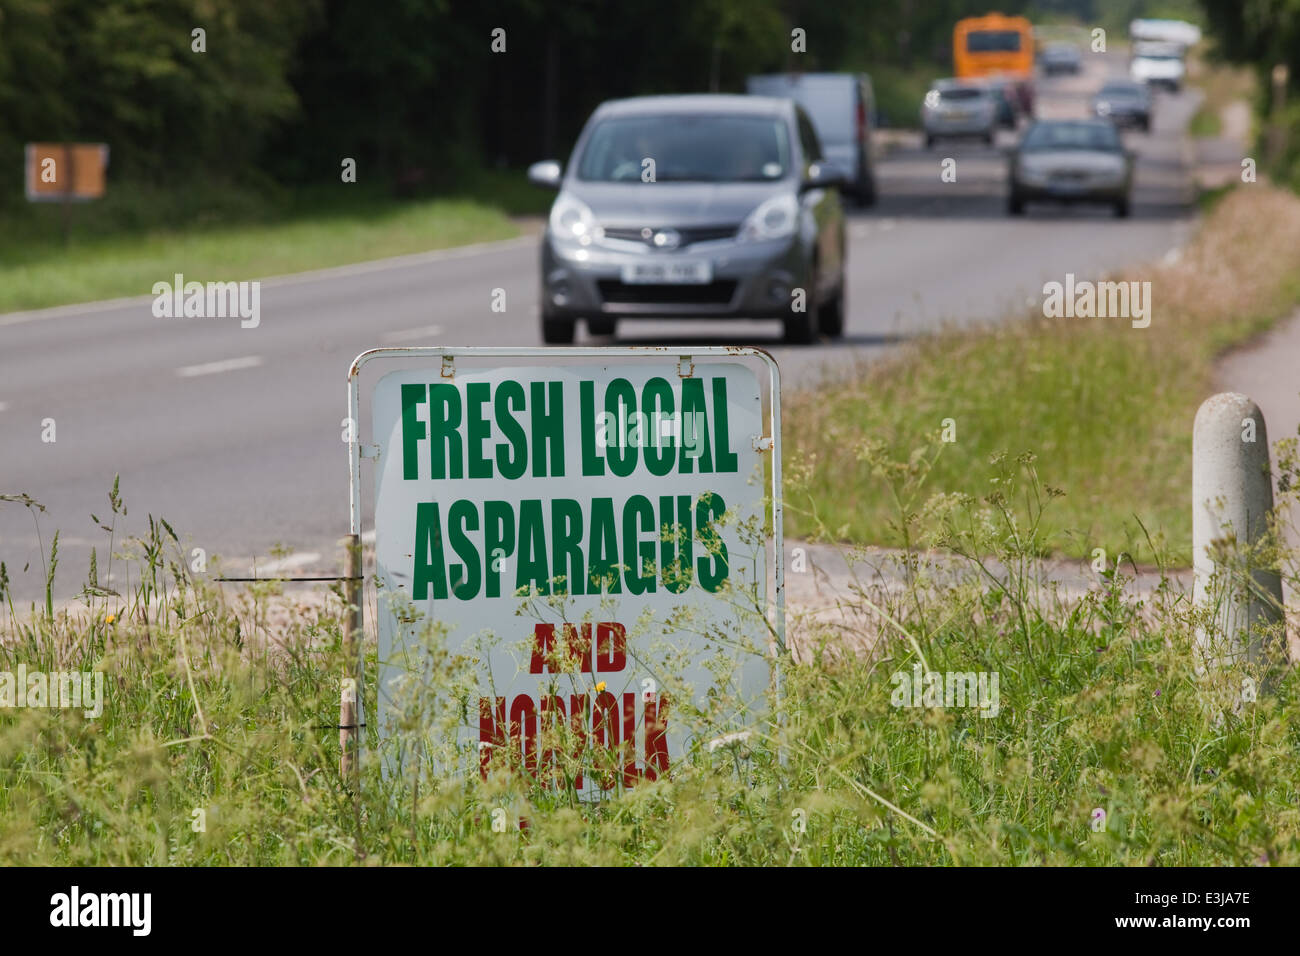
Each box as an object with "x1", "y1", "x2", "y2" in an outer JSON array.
[{"x1": 0, "y1": 455, "x2": 1300, "y2": 865}]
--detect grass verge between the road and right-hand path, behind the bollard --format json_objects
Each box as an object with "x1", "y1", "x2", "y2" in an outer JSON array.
[{"x1": 783, "y1": 182, "x2": 1300, "y2": 564}]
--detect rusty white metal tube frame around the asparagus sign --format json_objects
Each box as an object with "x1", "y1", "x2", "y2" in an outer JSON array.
[{"x1": 339, "y1": 345, "x2": 787, "y2": 775}]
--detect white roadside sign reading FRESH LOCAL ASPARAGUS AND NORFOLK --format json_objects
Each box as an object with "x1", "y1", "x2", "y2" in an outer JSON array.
[{"x1": 350, "y1": 347, "x2": 784, "y2": 796}]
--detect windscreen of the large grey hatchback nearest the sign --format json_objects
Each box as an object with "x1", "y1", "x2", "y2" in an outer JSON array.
[{"x1": 577, "y1": 113, "x2": 790, "y2": 182}]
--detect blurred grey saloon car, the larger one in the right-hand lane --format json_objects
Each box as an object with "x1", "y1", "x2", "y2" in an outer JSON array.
[{"x1": 1008, "y1": 120, "x2": 1134, "y2": 216}]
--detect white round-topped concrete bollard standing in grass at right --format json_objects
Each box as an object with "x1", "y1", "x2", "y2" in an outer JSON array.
[{"x1": 1192, "y1": 392, "x2": 1282, "y2": 666}]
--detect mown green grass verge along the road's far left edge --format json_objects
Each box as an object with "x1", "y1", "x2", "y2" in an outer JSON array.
[{"x1": 0, "y1": 170, "x2": 550, "y2": 312}]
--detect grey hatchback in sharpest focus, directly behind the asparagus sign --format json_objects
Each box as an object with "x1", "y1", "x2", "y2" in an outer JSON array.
[{"x1": 528, "y1": 95, "x2": 846, "y2": 345}]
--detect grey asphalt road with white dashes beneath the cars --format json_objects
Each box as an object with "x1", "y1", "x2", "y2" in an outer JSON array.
[{"x1": 0, "y1": 50, "x2": 1195, "y2": 600}]
